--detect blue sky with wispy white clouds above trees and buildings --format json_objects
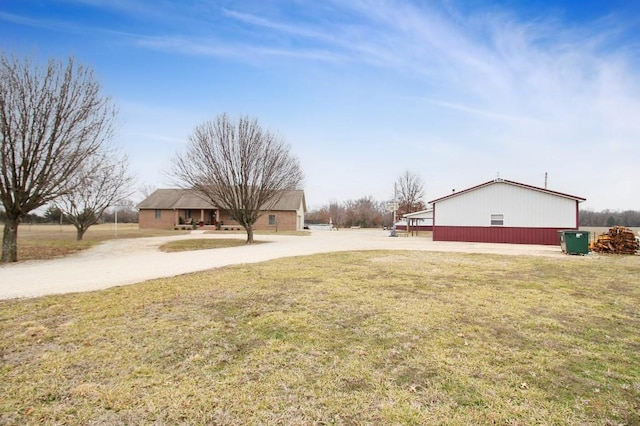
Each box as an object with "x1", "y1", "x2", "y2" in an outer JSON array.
[{"x1": 0, "y1": 0, "x2": 640, "y2": 210}]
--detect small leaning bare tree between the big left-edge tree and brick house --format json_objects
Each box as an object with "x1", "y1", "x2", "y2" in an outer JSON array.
[{"x1": 57, "y1": 151, "x2": 133, "y2": 241}]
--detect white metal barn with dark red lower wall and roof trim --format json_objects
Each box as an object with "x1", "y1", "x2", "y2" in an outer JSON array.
[{"x1": 429, "y1": 178, "x2": 585, "y2": 245}]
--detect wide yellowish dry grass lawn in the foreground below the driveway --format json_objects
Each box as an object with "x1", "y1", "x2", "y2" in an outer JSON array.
[{"x1": 0, "y1": 251, "x2": 640, "y2": 425}]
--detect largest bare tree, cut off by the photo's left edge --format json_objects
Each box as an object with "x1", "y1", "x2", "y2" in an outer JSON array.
[{"x1": 0, "y1": 53, "x2": 116, "y2": 262}]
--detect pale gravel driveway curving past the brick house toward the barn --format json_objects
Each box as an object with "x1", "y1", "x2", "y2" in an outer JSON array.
[{"x1": 0, "y1": 229, "x2": 563, "y2": 299}]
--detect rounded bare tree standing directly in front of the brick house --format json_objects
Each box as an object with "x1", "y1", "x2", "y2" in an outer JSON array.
[{"x1": 171, "y1": 114, "x2": 303, "y2": 244}]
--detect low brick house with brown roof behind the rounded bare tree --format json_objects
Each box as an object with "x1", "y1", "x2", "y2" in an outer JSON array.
[{"x1": 137, "y1": 188, "x2": 306, "y2": 231}]
